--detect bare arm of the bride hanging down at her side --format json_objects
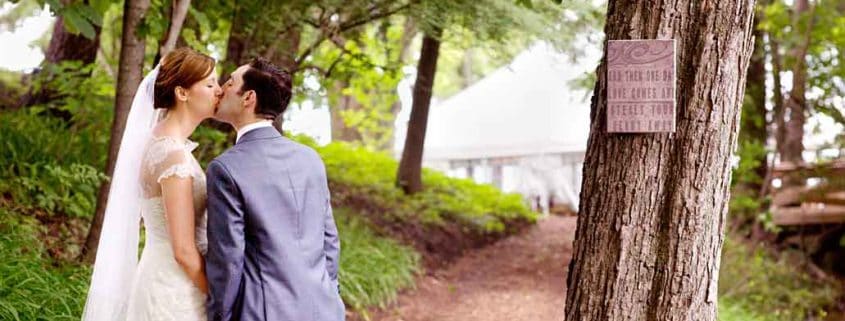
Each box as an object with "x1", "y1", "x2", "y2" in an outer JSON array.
[{"x1": 161, "y1": 176, "x2": 208, "y2": 293}]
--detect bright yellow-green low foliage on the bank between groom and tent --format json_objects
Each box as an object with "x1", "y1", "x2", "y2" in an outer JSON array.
[{"x1": 296, "y1": 137, "x2": 537, "y2": 234}]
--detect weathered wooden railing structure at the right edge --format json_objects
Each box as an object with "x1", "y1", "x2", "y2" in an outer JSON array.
[{"x1": 771, "y1": 159, "x2": 845, "y2": 226}]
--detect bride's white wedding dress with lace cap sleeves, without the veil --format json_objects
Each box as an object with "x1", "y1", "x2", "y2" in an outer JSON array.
[{"x1": 126, "y1": 136, "x2": 208, "y2": 321}]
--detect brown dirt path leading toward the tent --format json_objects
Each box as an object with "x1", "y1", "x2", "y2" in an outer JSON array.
[{"x1": 360, "y1": 216, "x2": 576, "y2": 321}]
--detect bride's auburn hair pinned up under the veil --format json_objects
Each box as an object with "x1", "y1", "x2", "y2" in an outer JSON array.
[{"x1": 153, "y1": 47, "x2": 214, "y2": 109}]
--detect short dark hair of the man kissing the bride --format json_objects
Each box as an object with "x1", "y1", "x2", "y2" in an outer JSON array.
[{"x1": 240, "y1": 57, "x2": 292, "y2": 119}]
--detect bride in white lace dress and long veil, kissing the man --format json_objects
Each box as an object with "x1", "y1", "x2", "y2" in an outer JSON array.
[{"x1": 82, "y1": 48, "x2": 221, "y2": 321}]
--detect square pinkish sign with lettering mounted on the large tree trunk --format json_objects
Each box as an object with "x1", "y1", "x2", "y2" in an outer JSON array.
[{"x1": 607, "y1": 40, "x2": 675, "y2": 133}]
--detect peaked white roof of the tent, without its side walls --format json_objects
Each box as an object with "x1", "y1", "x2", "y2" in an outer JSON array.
[{"x1": 423, "y1": 43, "x2": 598, "y2": 160}]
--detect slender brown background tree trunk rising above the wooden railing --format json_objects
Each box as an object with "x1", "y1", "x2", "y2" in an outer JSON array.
[{"x1": 781, "y1": 0, "x2": 812, "y2": 168}]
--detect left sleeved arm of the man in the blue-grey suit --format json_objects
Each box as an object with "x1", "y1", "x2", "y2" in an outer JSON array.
[{"x1": 206, "y1": 160, "x2": 244, "y2": 321}]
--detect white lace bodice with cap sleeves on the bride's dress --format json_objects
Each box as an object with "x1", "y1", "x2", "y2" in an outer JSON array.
[{"x1": 140, "y1": 136, "x2": 208, "y2": 254}]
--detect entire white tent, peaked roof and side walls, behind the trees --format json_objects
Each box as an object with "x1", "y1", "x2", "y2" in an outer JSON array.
[{"x1": 399, "y1": 43, "x2": 600, "y2": 210}]
